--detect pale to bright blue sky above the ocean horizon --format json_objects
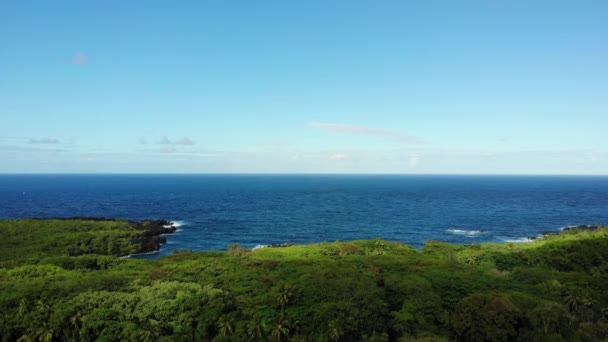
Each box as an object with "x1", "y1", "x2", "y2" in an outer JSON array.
[{"x1": 0, "y1": 0, "x2": 608, "y2": 174}]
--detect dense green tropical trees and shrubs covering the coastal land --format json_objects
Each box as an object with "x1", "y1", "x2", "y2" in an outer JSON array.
[{"x1": 0, "y1": 220, "x2": 608, "y2": 341}]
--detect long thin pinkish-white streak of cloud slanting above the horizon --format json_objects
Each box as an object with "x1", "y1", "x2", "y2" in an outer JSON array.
[{"x1": 307, "y1": 122, "x2": 425, "y2": 144}]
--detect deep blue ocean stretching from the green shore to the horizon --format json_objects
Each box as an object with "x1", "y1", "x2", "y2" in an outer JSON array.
[{"x1": 0, "y1": 175, "x2": 608, "y2": 254}]
